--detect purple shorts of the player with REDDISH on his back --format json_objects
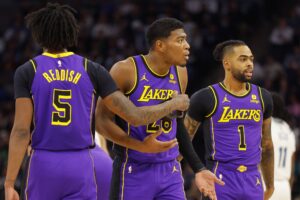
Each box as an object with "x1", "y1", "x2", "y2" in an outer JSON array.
[{"x1": 25, "y1": 149, "x2": 97, "y2": 200}]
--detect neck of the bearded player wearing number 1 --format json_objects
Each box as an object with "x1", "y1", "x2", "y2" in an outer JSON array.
[{"x1": 223, "y1": 77, "x2": 247, "y2": 95}]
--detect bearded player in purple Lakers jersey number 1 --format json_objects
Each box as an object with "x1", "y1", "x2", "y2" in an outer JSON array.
[{"x1": 185, "y1": 40, "x2": 274, "y2": 200}]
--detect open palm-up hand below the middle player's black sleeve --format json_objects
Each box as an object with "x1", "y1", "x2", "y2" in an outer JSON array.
[{"x1": 195, "y1": 170, "x2": 225, "y2": 200}]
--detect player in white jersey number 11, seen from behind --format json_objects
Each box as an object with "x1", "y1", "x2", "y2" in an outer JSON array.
[{"x1": 271, "y1": 93, "x2": 296, "y2": 200}]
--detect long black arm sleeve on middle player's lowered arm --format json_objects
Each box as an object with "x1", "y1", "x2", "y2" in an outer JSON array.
[{"x1": 176, "y1": 118, "x2": 205, "y2": 173}]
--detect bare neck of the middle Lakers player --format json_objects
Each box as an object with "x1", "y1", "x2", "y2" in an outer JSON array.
[{"x1": 145, "y1": 52, "x2": 171, "y2": 75}]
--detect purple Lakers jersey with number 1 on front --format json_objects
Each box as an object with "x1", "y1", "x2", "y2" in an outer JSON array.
[{"x1": 209, "y1": 83, "x2": 263, "y2": 165}]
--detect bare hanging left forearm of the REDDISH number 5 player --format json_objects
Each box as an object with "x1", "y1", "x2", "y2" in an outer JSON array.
[{"x1": 5, "y1": 130, "x2": 30, "y2": 187}]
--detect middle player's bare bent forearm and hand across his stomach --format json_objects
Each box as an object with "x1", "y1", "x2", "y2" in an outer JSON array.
[{"x1": 95, "y1": 100, "x2": 177, "y2": 153}]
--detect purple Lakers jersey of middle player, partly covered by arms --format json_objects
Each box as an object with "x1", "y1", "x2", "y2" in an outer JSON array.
[{"x1": 116, "y1": 55, "x2": 181, "y2": 163}]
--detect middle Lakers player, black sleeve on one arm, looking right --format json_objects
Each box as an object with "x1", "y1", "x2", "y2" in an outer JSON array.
[{"x1": 96, "y1": 18, "x2": 224, "y2": 200}]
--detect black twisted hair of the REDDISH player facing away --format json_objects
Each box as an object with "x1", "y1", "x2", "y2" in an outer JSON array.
[{"x1": 25, "y1": 3, "x2": 79, "y2": 51}]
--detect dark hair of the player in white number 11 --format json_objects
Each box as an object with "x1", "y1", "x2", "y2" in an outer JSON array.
[{"x1": 271, "y1": 92, "x2": 290, "y2": 123}]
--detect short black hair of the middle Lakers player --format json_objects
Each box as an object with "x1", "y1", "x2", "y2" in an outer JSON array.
[{"x1": 146, "y1": 17, "x2": 184, "y2": 47}]
